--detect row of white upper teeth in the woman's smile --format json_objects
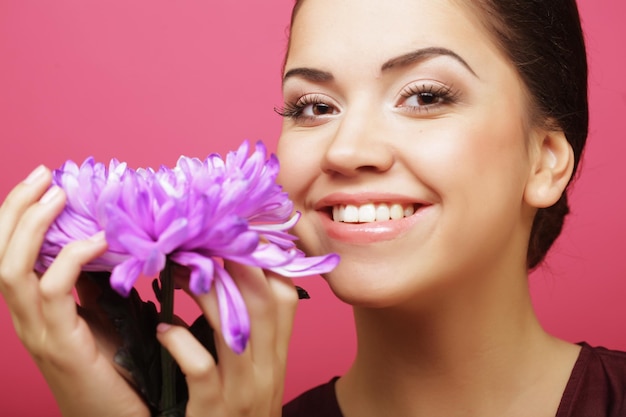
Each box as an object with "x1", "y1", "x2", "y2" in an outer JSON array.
[{"x1": 333, "y1": 203, "x2": 415, "y2": 223}]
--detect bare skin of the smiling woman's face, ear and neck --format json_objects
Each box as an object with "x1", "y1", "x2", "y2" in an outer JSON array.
[{"x1": 278, "y1": 0, "x2": 579, "y2": 417}]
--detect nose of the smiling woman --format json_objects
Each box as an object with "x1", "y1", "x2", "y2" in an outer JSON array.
[{"x1": 321, "y1": 108, "x2": 395, "y2": 177}]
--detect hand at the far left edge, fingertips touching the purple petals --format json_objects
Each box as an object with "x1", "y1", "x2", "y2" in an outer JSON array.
[{"x1": 0, "y1": 167, "x2": 149, "y2": 417}]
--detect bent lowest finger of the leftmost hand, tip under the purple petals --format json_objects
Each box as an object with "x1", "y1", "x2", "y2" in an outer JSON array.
[{"x1": 39, "y1": 232, "x2": 107, "y2": 335}]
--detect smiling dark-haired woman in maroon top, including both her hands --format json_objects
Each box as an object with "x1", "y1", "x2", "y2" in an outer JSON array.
[{"x1": 0, "y1": 0, "x2": 626, "y2": 417}]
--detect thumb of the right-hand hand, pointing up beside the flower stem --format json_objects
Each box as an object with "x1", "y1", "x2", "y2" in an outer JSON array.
[{"x1": 157, "y1": 323, "x2": 222, "y2": 415}]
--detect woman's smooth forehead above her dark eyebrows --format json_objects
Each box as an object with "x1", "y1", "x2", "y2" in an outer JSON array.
[{"x1": 287, "y1": 0, "x2": 499, "y2": 71}]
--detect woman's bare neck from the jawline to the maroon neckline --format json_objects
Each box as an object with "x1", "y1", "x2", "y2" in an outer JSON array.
[{"x1": 337, "y1": 271, "x2": 577, "y2": 416}]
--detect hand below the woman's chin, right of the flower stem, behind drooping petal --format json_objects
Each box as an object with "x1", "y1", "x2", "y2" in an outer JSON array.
[{"x1": 157, "y1": 264, "x2": 298, "y2": 417}]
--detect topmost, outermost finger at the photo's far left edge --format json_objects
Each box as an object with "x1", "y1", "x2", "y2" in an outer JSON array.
[{"x1": 0, "y1": 165, "x2": 51, "y2": 258}]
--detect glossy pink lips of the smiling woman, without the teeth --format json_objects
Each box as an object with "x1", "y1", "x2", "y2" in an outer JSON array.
[{"x1": 314, "y1": 193, "x2": 432, "y2": 244}]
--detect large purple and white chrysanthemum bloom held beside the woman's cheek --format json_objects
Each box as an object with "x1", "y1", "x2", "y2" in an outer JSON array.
[{"x1": 36, "y1": 142, "x2": 339, "y2": 353}]
